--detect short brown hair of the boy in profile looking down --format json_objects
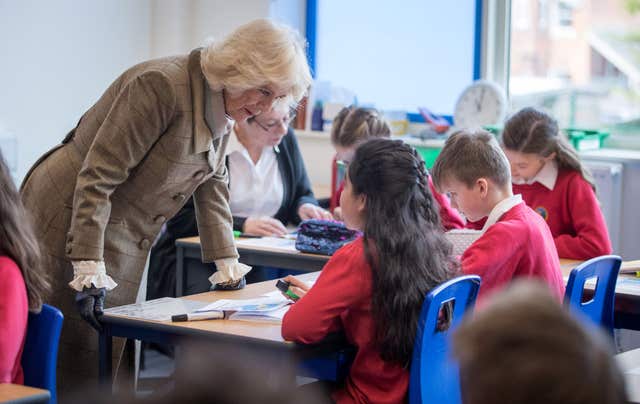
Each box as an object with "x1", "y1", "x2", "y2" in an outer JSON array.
[{"x1": 431, "y1": 129, "x2": 511, "y2": 192}]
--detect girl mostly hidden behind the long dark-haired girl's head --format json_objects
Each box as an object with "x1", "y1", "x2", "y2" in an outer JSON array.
[{"x1": 329, "y1": 106, "x2": 464, "y2": 230}]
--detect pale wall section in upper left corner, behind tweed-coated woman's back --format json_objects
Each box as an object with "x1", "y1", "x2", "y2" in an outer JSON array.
[{"x1": 0, "y1": 0, "x2": 150, "y2": 180}]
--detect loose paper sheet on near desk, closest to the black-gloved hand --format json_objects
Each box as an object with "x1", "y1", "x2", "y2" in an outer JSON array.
[{"x1": 104, "y1": 297, "x2": 206, "y2": 321}]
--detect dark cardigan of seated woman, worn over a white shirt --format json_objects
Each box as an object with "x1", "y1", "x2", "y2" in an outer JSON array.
[{"x1": 147, "y1": 128, "x2": 318, "y2": 299}]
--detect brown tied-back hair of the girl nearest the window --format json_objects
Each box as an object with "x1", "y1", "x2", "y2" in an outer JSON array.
[{"x1": 502, "y1": 107, "x2": 596, "y2": 191}]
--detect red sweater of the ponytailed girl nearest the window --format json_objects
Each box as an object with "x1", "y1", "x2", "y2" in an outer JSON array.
[{"x1": 513, "y1": 170, "x2": 611, "y2": 260}]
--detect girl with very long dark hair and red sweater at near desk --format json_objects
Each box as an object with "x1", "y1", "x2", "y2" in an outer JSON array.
[{"x1": 282, "y1": 139, "x2": 458, "y2": 403}]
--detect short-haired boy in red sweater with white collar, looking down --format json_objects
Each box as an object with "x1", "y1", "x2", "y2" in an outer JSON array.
[{"x1": 432, "y1": 130, "x2": 564, "y2": 300}]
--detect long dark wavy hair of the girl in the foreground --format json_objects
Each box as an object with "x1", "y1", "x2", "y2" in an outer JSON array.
[{"x1": 348, "y1": 139, "x2": 458, "y2": 366}]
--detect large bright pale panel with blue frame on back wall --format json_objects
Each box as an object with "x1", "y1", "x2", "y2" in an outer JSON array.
[{"x1": 308, "y1": 0, "x2": 481, "y2": 114}]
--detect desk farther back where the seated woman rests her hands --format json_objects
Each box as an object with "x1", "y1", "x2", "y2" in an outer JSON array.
[{"x1": 176, "y1": 237, "x2": 330, "y2": 297}]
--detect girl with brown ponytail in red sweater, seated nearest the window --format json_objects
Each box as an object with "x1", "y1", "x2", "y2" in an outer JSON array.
[{"x1": 502, "y1": 108, "x2": 611, "y2": 260}]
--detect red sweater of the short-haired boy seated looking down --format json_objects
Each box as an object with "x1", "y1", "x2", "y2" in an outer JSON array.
[{"x1": 462, "y1": 203, "x2": 564, "y2": 301}]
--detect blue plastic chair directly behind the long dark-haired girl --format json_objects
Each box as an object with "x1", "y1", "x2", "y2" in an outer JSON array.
[{"x1": 409, "y1": 275, "x2": 480, "y2": 404}]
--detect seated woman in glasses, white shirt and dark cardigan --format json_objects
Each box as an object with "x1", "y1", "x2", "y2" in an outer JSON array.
[{"x1": 147, "y1": 105, "x2": 332, "y2": 299}]
